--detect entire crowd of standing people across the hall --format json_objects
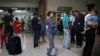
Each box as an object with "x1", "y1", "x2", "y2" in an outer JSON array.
[{"x1": 0, "y1": 4, "x2": 98, "y2": 56}]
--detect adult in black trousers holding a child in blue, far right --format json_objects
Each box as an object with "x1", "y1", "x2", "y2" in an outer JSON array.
[{"x1": 83, "y1": 4, "x2": 98, "y2": 56}]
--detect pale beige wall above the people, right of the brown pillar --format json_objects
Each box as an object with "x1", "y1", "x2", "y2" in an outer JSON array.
[{"x1": 47, "y1": 0, "x2": 100, "y2": 12}]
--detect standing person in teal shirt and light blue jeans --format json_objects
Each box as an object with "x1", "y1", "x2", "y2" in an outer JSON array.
[{"x1": 62, "y1": 13, "x2": 70, "y2": 50}]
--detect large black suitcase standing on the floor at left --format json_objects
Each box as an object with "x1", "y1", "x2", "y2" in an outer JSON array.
[{"x1": 7, "y1": 36, "x2": 22, "y2": 55}]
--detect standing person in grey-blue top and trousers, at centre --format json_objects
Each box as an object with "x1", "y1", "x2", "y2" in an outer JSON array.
[{"x1": 46, "y1": 11, "x2": 56, "y2": 56}]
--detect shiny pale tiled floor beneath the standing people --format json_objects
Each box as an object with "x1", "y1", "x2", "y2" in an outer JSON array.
[{"x1": 0, "y1": 34, "x2": 100, "y2": 56}]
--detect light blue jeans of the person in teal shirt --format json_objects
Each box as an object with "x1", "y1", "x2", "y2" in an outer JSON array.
[{"x1": 63, "y1": 29, "x2": 71, "y2": 49}]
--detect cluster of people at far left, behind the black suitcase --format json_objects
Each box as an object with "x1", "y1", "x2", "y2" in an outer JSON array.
[{"x1": 0, "y1": 9, "x2": 23, "y2": 49}]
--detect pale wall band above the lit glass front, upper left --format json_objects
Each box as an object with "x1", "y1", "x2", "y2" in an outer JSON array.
[{"x1": 0, "y1": 2, "x2": 38, "y2": 7}]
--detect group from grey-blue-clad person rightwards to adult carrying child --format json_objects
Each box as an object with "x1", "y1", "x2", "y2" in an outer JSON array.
[{"x1": 46, "y1": 3, "x2": 99, "y2": 56}]
